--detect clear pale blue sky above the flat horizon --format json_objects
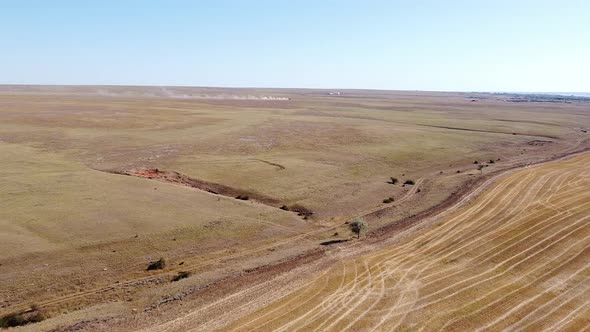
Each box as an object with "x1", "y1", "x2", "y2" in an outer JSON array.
[{"x1": 0, "y1": 0, "x2": 590, "y2": 92}]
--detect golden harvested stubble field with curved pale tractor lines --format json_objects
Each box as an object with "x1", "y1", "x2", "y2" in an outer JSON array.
[{"x1": 141, "y1": 154, "x2": 590, "y2": 331}]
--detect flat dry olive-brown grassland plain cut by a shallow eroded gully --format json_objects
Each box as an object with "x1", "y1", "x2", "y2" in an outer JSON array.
[{"x1": 0, "y1": 87, "x2": 590, "y2": 326}]
